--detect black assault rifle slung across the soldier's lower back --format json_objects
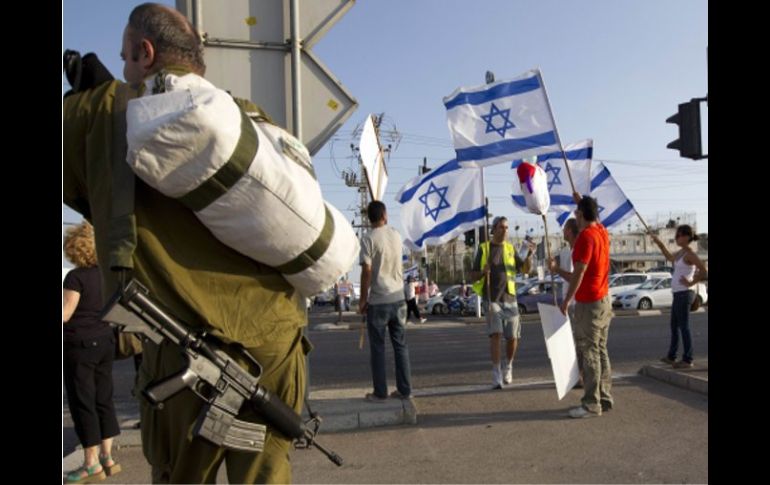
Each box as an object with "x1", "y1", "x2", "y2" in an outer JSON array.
[{"x1": 102, "y1": 279, "x2": 342, "y2": 466}]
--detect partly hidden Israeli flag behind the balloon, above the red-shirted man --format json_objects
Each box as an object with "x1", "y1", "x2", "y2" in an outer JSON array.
[{"x1": 511, "y1": 139, "x2": 593, "y2": 214}]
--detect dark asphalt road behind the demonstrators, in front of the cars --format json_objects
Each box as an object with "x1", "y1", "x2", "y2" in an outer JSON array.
[{"x1": 309, "y1": 312, "x2": 708, "y2": 389}]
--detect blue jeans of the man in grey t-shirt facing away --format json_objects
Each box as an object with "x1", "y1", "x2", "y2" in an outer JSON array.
[{"x1": 366, "y1": 301, "x2": 412, "y2": 397}]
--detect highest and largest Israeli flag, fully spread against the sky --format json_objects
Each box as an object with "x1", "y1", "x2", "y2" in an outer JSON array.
[{"x1": 444, "y1": 69, "x2": 559, "y2": 167}]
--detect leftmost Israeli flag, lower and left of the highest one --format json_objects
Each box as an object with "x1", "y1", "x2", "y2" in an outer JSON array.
[{"x1": 396, "y1": 160, "x2": 484, "y2": 250}]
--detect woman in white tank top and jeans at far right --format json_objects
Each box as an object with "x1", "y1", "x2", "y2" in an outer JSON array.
[{"x1": 650, "y1": 224, "x2": 708, "y2": 369}]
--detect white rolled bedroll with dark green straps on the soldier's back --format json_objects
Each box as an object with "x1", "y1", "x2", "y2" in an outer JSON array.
[{"x1": 126, "y1": 74, "x2": 359, "y2": 297}]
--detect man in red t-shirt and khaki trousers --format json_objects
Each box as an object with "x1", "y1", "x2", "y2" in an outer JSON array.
[{"x1": 561, "y1": 194, "x2": 613, "y2": 418}]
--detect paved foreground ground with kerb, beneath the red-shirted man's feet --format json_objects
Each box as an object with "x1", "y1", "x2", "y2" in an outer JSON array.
[{"x1": 62, "y1": 361, "x2": 708, "y2": 484}]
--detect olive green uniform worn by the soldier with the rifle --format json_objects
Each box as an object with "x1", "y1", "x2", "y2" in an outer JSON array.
[{"x1": 63, "y1": 81, "x2": 309, "y2": 483}]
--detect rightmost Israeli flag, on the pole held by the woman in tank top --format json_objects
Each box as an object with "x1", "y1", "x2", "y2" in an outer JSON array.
[{"x1": 556, "y1": 160, "x2": 635, "y2": 228}]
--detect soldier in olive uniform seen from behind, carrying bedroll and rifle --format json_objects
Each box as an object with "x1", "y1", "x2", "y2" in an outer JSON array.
[{"x1": 63, "y1": 4, "x2": 310, "y2": 483}]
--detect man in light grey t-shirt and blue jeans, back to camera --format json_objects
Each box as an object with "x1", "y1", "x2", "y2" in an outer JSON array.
[{"x1": 358, "y1": 200, "x2": 412, "y2": 402}]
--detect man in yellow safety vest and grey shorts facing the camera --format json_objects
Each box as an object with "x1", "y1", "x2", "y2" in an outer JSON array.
[{"x1": 471, "y1": 217, "x2": 535, "y2": 389}]
